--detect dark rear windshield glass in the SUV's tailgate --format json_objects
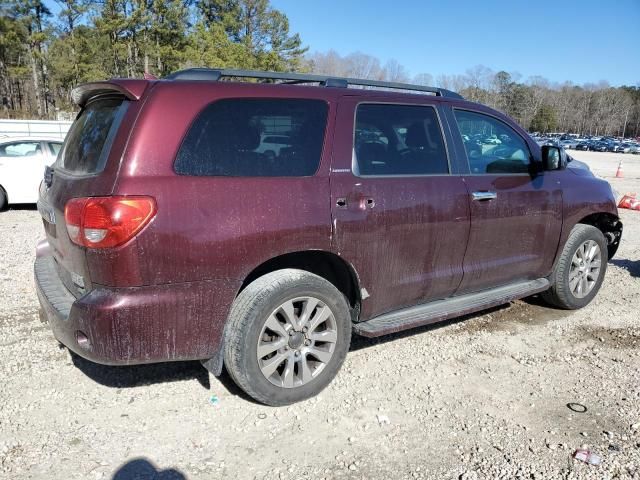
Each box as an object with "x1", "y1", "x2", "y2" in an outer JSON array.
[{"x1": 56, "y1": 97, "x2": 127, "y2": 174}]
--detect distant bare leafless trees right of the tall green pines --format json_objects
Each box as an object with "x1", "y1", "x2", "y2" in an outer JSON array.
[{"x1": 308, "y1": 51, "x2": 640, "y2": 137}]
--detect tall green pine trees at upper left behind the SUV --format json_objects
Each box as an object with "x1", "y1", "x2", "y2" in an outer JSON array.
[{"x1": 0, "y1": 0, "x2": 307, "y2": 118}]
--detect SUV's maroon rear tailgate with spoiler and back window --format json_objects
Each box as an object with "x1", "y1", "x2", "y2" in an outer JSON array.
[{"x1": 38, "y1": 81, "x2": 148, "y2": 298}]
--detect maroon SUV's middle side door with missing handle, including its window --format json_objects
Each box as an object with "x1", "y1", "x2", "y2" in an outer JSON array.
[{"x1": 331, "y1": 97, "x2": 469, "y2": 320}]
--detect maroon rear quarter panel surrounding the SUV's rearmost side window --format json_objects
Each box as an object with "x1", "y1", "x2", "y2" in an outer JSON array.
[{"x1": 98, "y1": 82, "x2": 335, "y2": 287}]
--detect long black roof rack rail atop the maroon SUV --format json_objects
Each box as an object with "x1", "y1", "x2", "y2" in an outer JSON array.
[{"x1": 164, "y1": 68, "x2": 463, "y2": 99}]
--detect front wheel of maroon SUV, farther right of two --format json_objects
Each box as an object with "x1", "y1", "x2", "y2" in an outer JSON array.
[{"x1": 542, "y1": 224, "x2": 608, "y2": 310}]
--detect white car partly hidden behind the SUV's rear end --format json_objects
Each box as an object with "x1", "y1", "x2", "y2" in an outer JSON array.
[{"x1": 0, "y1": 137, "x2": 63, "y2": 209}]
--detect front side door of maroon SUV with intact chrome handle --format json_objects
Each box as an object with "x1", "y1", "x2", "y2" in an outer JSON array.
[{"x1": 452, "y1": 109, "x2": 562, "y2": 294}]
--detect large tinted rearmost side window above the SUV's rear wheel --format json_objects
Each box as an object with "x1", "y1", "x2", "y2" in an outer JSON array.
[{"x1": 174, "y1": 99, "x2": 328, "y2": 177}]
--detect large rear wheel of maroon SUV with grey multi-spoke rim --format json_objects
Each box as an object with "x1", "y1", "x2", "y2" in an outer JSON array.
[{"x1": 224, "y1": 269, "x2": 351, "y2": 406}]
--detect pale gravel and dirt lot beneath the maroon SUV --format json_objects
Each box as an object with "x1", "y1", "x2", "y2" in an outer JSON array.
[{"x1": 0, "y1": 152, "x2": 640, "y2": 480}]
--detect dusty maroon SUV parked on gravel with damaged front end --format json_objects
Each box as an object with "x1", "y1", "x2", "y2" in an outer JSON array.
[{"x1": 35, "y1": 69, "x2": 622, "y2": 405}]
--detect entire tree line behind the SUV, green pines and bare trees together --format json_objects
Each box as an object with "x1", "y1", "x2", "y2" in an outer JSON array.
[{"x1": 0, "y1": 0, "x2": 640, "y2": 137}]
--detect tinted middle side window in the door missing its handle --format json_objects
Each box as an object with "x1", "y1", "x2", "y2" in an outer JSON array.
[{"x1": 353, "y1": 104, "x2": 449, "y2": 175}]
